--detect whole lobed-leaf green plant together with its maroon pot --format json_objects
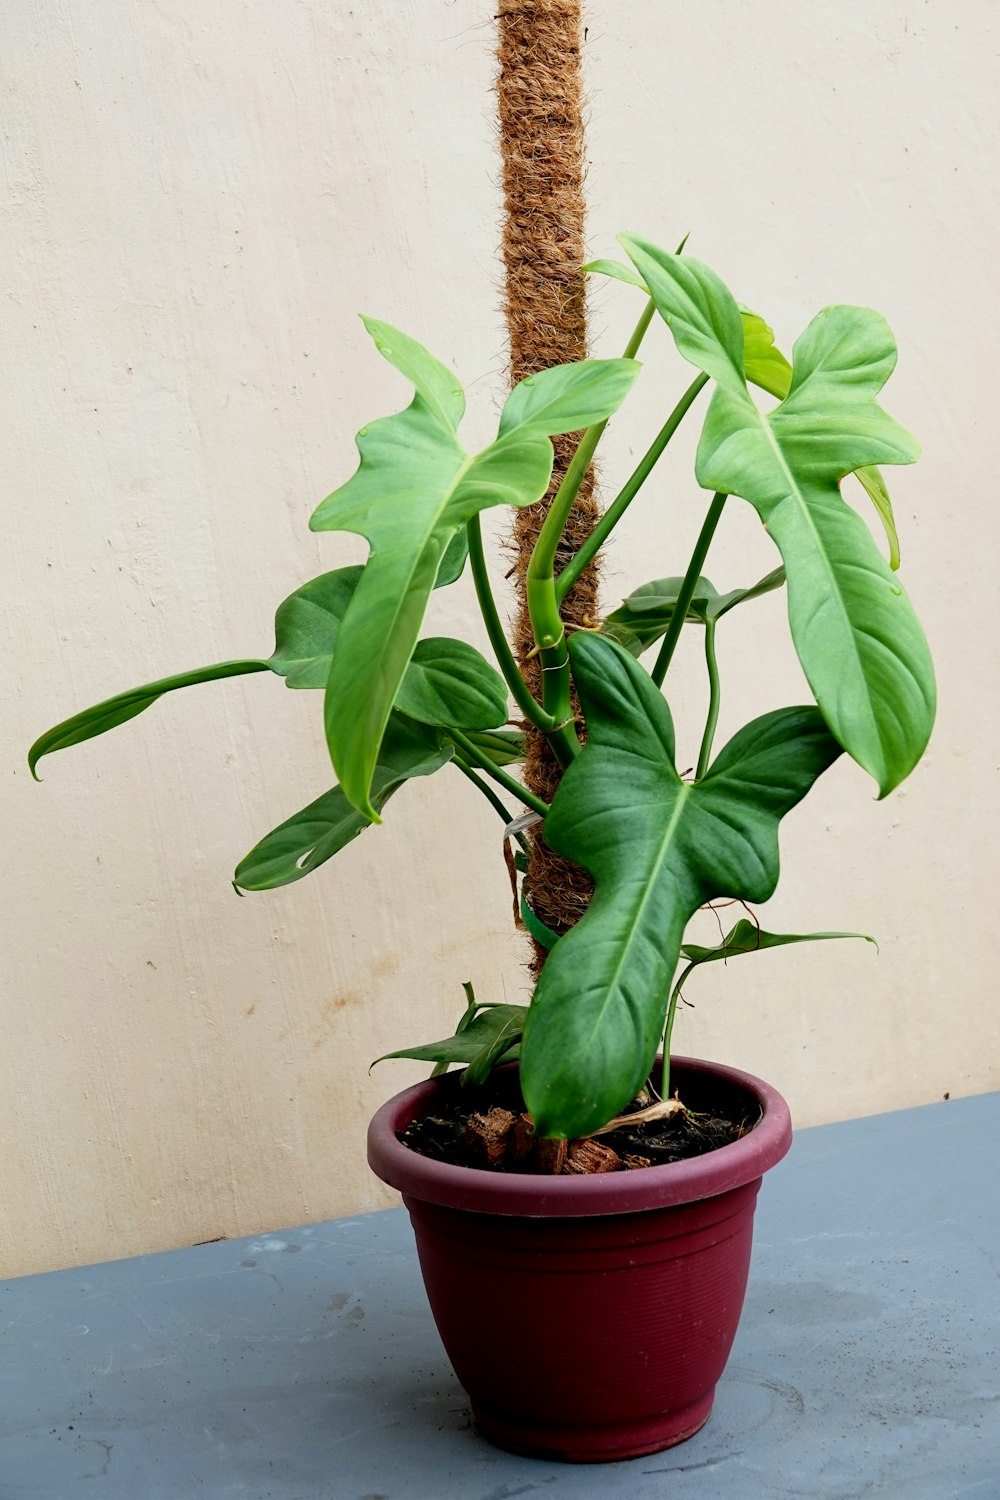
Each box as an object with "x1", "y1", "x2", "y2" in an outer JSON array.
[{"x1": 30, "y1": 236, "x2": 934, "y2": 1460}]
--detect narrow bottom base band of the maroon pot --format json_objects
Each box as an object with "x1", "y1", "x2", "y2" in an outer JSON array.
[{"x1": 472, "y1": 1391, "x2": 715, "y2": 1464}]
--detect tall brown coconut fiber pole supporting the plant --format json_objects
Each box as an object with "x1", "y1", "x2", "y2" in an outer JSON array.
[{"x1": 496, "y1": 0, "x2": 598, "y2": 968}]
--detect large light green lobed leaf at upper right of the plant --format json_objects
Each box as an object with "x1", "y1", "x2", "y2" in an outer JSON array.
[{"x1": 622, "y1": 236, "x2": 936, "y2": 797}]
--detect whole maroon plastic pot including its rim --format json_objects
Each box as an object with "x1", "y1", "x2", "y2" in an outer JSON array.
[{"x1": 369, "y1": 1058, "x2": 792, "y2": 1463}]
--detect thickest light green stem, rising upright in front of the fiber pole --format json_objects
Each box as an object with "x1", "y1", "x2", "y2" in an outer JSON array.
[{"x1": 525, "y1": 297, "x2": 655, "y2": 767}]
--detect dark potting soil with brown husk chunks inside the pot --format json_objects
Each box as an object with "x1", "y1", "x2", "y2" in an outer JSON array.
[{"x1": 399, "y1": 1070, "x2": 759, "y2": 1175}]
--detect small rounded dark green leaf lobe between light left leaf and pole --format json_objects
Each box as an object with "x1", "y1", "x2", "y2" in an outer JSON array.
[{"x1": 396, "y1": 636, "x2": 507, "y2": 729}]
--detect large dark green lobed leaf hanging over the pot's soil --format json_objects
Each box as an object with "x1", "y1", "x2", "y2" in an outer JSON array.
[{"x1": 522, "y1": 633, "x2": 841, "y2": 1137}]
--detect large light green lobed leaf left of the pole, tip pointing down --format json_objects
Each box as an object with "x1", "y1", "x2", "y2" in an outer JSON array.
[{"x1": 310, "y1": 320, "x2": 639, "y2": 821}]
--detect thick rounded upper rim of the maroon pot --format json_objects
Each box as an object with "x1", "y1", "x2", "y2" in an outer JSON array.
[{"x1": 367, "y1": 1058, "x2": 792, "y2": 1218}]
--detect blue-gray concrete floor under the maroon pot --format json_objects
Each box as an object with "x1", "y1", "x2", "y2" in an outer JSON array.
[{"x1": 0, "y1": 1095, "x2": 1000, "y2": 1500}]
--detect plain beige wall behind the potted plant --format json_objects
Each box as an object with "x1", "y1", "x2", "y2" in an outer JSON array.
[{"x1": 0, "y1": 0, "x2": 1000, "y2": 1274}]
